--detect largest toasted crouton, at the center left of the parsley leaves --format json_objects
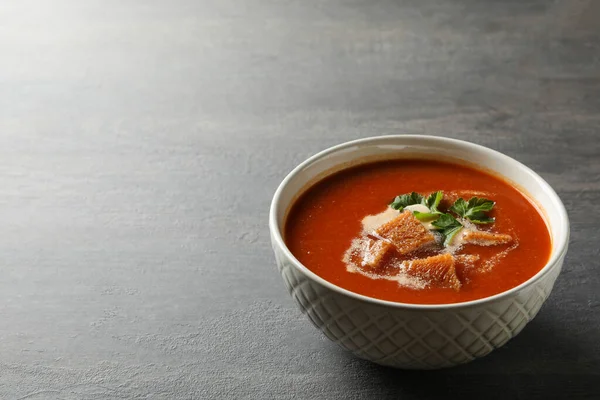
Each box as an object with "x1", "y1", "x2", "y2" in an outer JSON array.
[{"x1": 375, "y1": 211, "x2": 435, "y2": 255}]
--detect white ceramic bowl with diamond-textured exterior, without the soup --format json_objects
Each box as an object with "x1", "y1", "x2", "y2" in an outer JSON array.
[{"x1": 269, "y1": 135, "x2": 569, "y2": 369}]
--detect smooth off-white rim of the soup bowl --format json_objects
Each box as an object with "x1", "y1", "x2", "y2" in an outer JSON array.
[{"x1": 269, "y1": 135, "x2": 570, "y2": 310}]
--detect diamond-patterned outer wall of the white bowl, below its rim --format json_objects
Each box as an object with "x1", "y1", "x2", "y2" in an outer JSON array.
[{"x1": 274, "y1": 239, "x2": 563, "y2": 369}]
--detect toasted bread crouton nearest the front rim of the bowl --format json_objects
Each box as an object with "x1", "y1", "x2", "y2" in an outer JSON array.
[{"x1": 403, "y1": 253, "x2": 461, "y2": 290}]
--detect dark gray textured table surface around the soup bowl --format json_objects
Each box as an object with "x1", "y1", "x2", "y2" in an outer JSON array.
[{"x1": 0, "y1": 0, "x2": 600, "y2": 400}]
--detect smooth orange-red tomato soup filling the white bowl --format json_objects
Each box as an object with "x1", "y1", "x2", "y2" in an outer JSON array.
[{"x1": 285, "y1": 159, "x2": 551, "y2": 304}]
